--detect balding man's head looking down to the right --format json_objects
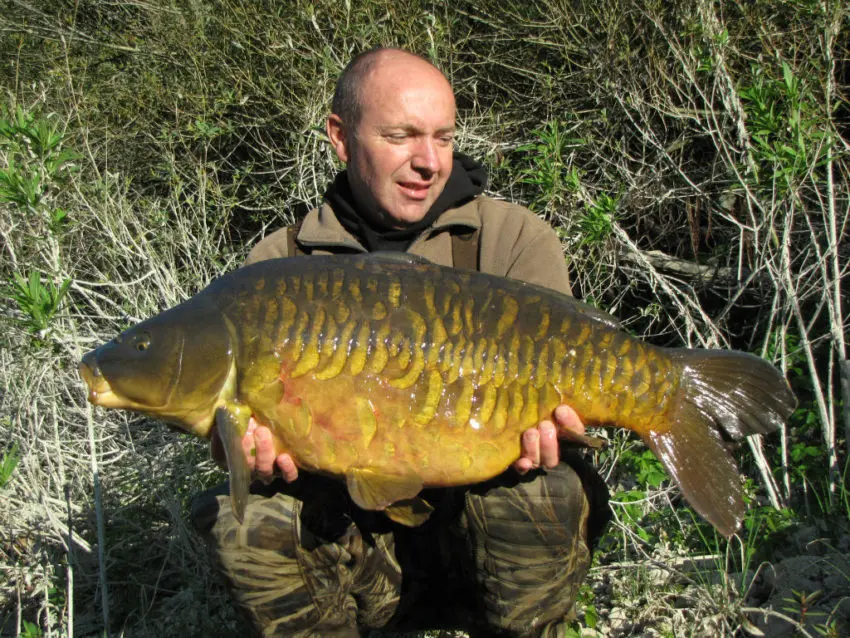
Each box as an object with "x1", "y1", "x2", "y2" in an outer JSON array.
[{"x1": 327, "y1": 49, "x2": 455, "y2": 227}]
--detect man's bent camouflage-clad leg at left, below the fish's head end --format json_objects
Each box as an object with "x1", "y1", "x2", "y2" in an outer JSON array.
[{"x1": 191, "y1": 486, "x2": 401, "y2": 637}]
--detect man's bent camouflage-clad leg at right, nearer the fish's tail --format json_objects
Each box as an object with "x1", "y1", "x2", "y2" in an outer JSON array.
[{"x1": 461, "y1": 456, "x2": 609, "y2": 634}]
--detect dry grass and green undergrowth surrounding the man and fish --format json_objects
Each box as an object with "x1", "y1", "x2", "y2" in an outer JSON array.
[{"x1": 0, "y1": 0, "x2": 850, "y2": 636}]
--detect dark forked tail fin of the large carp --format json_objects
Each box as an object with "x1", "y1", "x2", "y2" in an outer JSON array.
[{"x1": 642, "y1": 350, "x2": 796, "y2": 536}]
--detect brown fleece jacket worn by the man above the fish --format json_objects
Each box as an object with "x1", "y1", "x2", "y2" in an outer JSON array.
[{"x1": 245, "y1": 196, "x2": 570, "y2": 294}]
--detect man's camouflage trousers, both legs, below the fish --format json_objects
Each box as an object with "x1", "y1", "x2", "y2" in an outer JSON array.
[{"x1": 192, "y1": 453, "x2": 609, "y2": 638}]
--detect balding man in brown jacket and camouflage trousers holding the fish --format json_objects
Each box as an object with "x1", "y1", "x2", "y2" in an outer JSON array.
[{"x1": 193, "y1": 49, "x2": 608, "y2": 637}]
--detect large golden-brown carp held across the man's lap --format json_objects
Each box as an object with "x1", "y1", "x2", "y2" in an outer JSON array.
[{"x1": 80, "y1": 255, "x2": 795, "y2": 535}]
